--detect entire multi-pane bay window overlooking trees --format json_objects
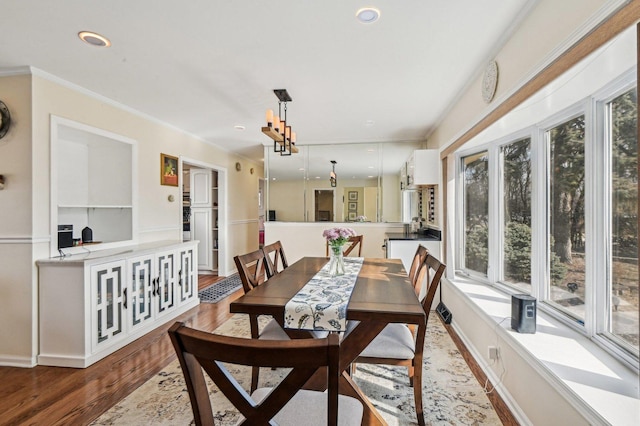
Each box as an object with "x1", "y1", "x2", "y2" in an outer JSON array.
[{"x1": 457, "y1": 89, "x2": 640, "y2": 364}]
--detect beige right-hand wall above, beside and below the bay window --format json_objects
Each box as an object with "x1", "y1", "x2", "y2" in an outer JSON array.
[{"x1": 428, "y1": 0, "x2": 632, "y2": 424}]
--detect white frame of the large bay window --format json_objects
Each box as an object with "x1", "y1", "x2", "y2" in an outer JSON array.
[{"x1": 455, "y1": 72, "x2": 640, "y2": 370}]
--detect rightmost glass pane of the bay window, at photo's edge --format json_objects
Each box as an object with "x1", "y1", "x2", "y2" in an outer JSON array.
[{"x1": 604, "y1": 88, "x2": 639, "y2": 353}]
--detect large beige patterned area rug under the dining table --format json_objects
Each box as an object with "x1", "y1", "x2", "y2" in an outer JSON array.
[{"x1": 92, "y1": 314, "x2": 502, "y2": 426}]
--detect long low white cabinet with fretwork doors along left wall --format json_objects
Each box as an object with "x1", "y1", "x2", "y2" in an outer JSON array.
[{"x1": 37, "y1": 242, "x2": 200, "y2": 367}]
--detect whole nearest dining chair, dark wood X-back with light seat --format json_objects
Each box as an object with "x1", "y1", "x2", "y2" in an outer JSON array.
[{"x1": 169, "y1": 322, "x2": 363, "y2": 426}]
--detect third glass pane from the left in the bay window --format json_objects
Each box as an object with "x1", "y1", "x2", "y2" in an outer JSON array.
[{"x1": 545, "y1": 115, "x2": 585, "y2": 323}]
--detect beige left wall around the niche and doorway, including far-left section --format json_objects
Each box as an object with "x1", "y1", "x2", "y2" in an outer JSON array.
[{"x1": 0, "y1": 71, "x2": 263, "y2": 366}]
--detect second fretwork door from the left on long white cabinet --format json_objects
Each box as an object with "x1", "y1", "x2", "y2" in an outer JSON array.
[{"x1": 127, "y1": 255, "x2": 156, "y2": 329}]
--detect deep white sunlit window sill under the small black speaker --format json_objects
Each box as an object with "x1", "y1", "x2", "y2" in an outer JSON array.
[{"x1": 443, "y1": 277, "x2": 640, "y2": 425}]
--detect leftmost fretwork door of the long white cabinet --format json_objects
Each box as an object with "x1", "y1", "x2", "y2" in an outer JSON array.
[{"x1": 90, "y1": 260, "x2": 127, "y2": 351}]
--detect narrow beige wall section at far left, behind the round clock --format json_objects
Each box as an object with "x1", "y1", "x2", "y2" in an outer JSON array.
[{"x1": 0, "y1": 76, "x2": 37, "y2": 365}]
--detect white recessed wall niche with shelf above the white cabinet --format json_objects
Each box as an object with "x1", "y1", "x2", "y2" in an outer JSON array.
[{"x1": 51, "y1": 117, "x2": 137, "y2": 256}]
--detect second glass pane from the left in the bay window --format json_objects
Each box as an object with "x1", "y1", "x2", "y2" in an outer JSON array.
[{"x1": 501, "y1": 138, "x2": 531, "y2": 293}]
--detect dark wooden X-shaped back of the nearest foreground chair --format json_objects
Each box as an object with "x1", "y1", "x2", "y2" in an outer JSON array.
[{"x1": 169, "y1": 322, "x2": 340, "y2": 425}]
